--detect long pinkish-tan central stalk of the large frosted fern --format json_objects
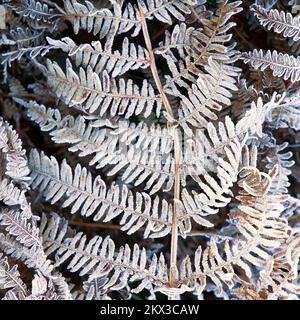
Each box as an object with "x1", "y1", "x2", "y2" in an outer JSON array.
[{"x1": 139, "y1": 6, "x2": 181, "y2": 288}]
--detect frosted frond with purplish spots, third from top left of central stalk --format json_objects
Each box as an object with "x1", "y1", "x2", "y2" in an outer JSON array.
[{"x1": 46, "y1": 60, "x2": 162, "y2": 118}]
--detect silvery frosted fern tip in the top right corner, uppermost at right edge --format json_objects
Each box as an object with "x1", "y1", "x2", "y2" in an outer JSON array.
[{"x1": 251, "y1": 5, "x2": 300, "y2": 41}]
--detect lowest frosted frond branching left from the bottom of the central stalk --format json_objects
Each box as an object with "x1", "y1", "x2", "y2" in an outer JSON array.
[{"x1": 41, "y1": 212, "x2": 168, "y2": 293}]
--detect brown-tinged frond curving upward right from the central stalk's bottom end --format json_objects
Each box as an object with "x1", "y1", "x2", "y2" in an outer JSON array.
[{"x1": 179, "y1": 168, "x2": 290, "y2": 293}]
